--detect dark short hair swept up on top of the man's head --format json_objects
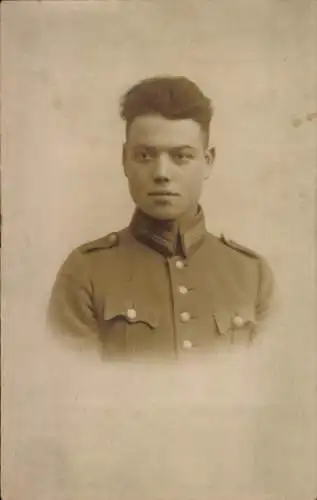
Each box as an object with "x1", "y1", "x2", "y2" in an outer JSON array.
[{"x1": 120, "y1": 76, "x2": 213, "y2": 141}]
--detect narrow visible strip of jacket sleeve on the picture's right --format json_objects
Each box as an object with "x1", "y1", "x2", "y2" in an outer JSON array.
[{"x1": 256, "y1": 257, "x2": 275, "y2": 321}]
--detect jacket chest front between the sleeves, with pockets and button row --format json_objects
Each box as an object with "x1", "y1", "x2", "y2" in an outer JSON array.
[{"x1": 89, "y1": 246, "x2": 256, "y2": 356}]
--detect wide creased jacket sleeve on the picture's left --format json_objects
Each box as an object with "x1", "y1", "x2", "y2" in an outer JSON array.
[{"x1": 47, "y1": 249, "x2": 98, "y2": 337}]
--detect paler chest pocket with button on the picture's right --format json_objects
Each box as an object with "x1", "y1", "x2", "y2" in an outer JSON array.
[{"x1": 214, "y1": 306, "x2": 256, "y2": 345}]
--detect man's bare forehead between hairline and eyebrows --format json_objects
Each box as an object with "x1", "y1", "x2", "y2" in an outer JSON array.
[{"x1": 128, "y1": 115, "x2": 203, "y2": 148}]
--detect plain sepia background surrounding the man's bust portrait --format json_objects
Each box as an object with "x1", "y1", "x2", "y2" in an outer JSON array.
[{"x1": 1, "y1": 0, "x2": 317, "y2": 500}]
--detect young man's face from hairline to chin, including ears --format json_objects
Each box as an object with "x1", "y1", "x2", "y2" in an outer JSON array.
[{"x1": 123, "y1": 115, "x2": 213, "y2": 220}]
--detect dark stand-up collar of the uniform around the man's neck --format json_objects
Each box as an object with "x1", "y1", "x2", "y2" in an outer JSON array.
[{"x1": 130, "y1": 206, "x2": 206, "y2": 257}]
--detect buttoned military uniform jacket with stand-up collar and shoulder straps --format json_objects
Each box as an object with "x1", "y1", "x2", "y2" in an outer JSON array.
[{"x1": 49, "y1": 209, "x2": 273, "y2": 357}]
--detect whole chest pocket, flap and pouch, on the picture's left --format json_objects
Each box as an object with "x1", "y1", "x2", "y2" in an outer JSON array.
[{"x1": 100, "y1": 294, "x2": 160, "y2": 354}]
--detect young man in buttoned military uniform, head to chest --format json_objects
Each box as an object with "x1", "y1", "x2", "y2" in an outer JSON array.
[{"x1": 49, "y1": 77, "x2": 273, "y2": 357}]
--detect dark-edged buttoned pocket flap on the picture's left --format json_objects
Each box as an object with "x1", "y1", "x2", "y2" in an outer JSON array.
[{"x1": 104, "y1": 295, "x2": 159, "y2": 328}]
